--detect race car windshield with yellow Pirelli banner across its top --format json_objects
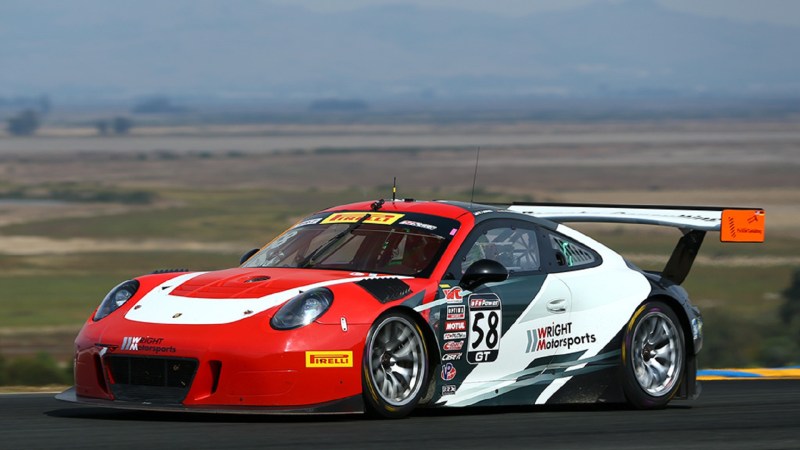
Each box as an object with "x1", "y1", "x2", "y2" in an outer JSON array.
[{"x1": 243, "y1": 212, "x2": 459, "y2": 276}]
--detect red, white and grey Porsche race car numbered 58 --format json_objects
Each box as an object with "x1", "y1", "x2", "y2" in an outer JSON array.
[{"x1": 57, "y1": 199, "x2": 765, "y2": 418}]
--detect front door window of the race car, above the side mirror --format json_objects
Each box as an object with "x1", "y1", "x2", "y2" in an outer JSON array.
[{"x1": 461, "y1": 226, "x2": 541, "y2": 274}]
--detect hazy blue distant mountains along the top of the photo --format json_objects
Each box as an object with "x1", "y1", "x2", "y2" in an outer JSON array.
[{"x1": 0, "y1": 0, "x2": 800, "y2": 99}]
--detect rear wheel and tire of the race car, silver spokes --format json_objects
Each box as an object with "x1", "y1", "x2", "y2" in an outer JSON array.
[{"x1": 622, "y1": 300, "x2": 686, "y2": 409}]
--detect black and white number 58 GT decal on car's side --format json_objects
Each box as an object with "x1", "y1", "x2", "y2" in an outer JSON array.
[{"x1": 467, "y1": 293, "x2": 503, "y2": 364}]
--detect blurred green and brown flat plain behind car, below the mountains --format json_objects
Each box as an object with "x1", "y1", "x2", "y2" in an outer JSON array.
[{"x1": 0, "y1": 119, "x2": 800, "y2": 384}]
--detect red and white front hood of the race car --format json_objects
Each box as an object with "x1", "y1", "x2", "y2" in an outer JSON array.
[{"x1": 125, "y1": 268, "x2": 412, "y2": 325}]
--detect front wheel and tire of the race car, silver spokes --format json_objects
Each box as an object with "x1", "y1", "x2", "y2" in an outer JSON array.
[{"x1": 362, "y1": 311, "x2": 430, "y2": 419}]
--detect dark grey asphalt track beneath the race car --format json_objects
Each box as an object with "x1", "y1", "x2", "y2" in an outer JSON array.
[{"x1": 0, "y1": 380, "x2": 800, "y2": 450}]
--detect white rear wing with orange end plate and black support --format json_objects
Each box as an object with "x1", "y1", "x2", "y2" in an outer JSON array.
[{"x1": 507, "y1": 203, "x2": 766, "y2": 284}]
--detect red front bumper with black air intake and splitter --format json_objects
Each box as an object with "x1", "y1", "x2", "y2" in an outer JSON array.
[{"x1": 68, "y1": 320, "x2": 368, "y2": 414}]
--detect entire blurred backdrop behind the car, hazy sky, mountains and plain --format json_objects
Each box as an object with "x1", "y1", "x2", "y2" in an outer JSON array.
[{"x1": 0, "y1": 0, "x2": 800, "y2": 385}]
